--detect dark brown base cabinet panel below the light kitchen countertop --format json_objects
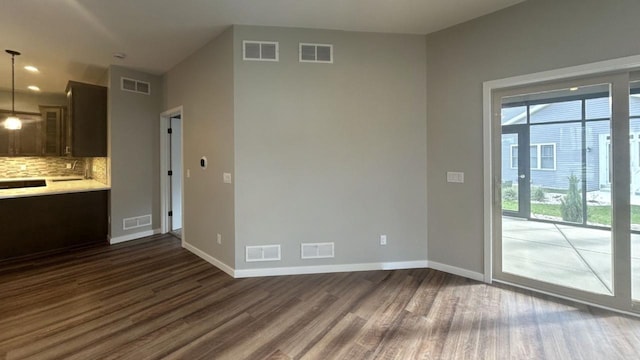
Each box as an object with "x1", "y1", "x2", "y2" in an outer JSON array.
[{"x1": 0, "y1": 190, "x2": 109, "y2": 260}]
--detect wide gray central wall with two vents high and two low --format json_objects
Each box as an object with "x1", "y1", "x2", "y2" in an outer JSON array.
[{"x1": 232, "y1": 26, "x2": 427, "y2": 269}]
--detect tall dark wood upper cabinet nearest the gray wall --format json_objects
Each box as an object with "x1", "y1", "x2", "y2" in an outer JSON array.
[{"x1": 64, "y1": 81, "x2": 107, "y2": 157}]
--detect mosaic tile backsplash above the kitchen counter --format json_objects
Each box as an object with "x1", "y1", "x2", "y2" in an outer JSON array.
[{"x1": 0, "y1": 157, "x2": 107, "y2": 184}]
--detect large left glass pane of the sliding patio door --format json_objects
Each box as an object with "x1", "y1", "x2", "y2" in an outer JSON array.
[{"x1": 499, "y1": 84, "x2": 616, "y2": 295}]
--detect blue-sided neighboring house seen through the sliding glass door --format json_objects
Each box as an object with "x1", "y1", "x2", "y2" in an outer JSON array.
[{"x1": 502, "y1": 95, "x2": 640, "y2": 193}]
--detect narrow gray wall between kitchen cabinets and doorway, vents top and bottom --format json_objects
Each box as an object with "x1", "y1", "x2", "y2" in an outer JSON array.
[{"x1": 109, "y1": 65, "x2": 162, "y2": 238}]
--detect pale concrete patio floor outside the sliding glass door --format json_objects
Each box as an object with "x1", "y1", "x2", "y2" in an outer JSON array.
[{"x1": 502, "y1": 217, "x2": 640, "y2": 301}]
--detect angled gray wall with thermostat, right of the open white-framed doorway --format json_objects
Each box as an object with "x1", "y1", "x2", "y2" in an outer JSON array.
[{"x1": 163, "y1": 28, "x2": 235, "y2": 267}]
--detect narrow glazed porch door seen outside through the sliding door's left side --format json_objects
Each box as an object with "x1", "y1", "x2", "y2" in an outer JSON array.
[{"x1": 502, "y1": 125, "x2": 531, "y2": 218}]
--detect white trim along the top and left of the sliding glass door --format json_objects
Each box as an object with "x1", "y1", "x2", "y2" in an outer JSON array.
[{"x1": 482, "y1": 55, "x2": 640, "y2": 283}]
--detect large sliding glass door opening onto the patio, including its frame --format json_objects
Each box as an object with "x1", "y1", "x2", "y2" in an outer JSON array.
[{"x1": 492, "y1": 74, "x2": 640, "y2": 310}]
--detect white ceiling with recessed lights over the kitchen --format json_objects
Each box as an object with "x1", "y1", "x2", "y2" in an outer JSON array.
[{"x1": 0, "y1": 0, "x2": 523, "y2": 92}]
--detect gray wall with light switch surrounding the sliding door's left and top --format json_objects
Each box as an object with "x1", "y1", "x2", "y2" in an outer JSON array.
[{"x1": 426, "y1": 0, "x2": 640, "y2": 272}]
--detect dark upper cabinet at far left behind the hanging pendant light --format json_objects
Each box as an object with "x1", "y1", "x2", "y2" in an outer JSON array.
[{"x1": 0, "y1": 112, "x2": 42, "y2": 156}]
